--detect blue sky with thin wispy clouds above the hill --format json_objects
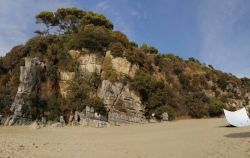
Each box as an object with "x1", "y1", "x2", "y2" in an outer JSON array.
[{"x1": 0, "y1": 0, "x2": 250, "y2": 77}]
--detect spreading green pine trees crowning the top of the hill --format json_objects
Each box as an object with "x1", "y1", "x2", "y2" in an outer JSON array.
[{"x1": 36, "y1": 8, "x2": 113, "y2": 35}]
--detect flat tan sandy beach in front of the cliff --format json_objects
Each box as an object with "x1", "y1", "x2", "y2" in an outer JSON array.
[{"x1": 0, "y1": 118, "x2": 250, "y2": 158}]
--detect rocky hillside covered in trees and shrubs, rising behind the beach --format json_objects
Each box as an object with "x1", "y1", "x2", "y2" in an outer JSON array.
[{"x1": 0, "y1": 8, "x2": 250, "y2": 124}]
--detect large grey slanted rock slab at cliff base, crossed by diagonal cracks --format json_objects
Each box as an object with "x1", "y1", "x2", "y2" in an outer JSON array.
[{"x1": 98, "y1": 80, "x2": 145, "y2": 123}]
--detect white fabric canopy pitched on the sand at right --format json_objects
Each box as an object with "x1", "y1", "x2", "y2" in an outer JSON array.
[{"x1": 223, "y1": 108, "x2": 250, "y2": 127}]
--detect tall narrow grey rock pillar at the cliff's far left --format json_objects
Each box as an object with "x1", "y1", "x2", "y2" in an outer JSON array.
[{"x1": 5, "y1": 57, "x2": 45, "y2": 125}]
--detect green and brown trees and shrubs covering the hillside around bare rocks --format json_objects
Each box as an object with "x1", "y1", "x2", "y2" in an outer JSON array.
[{"x1": 0, "y1": 8, "x2": 250, "y2": 119}]
